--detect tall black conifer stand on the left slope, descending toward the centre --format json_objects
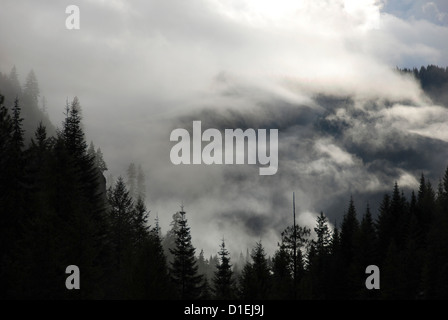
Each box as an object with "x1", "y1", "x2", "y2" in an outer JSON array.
[{"x1": 0, "y1": 96, "x2": 178, "y2": 299}]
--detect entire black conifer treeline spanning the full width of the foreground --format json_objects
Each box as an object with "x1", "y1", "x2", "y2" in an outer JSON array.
[{"x1": 0, "y1": 65, "x2": 448, "y2": 300}]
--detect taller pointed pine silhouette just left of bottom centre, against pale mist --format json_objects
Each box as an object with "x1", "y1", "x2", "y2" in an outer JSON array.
[{"x1": 170, "y1": 208, "x2": 203, "y2": 299}]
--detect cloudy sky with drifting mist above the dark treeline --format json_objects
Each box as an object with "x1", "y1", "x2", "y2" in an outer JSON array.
[{"x1": 0, "y1": 0, "x2": 448, "y2": 254}]
